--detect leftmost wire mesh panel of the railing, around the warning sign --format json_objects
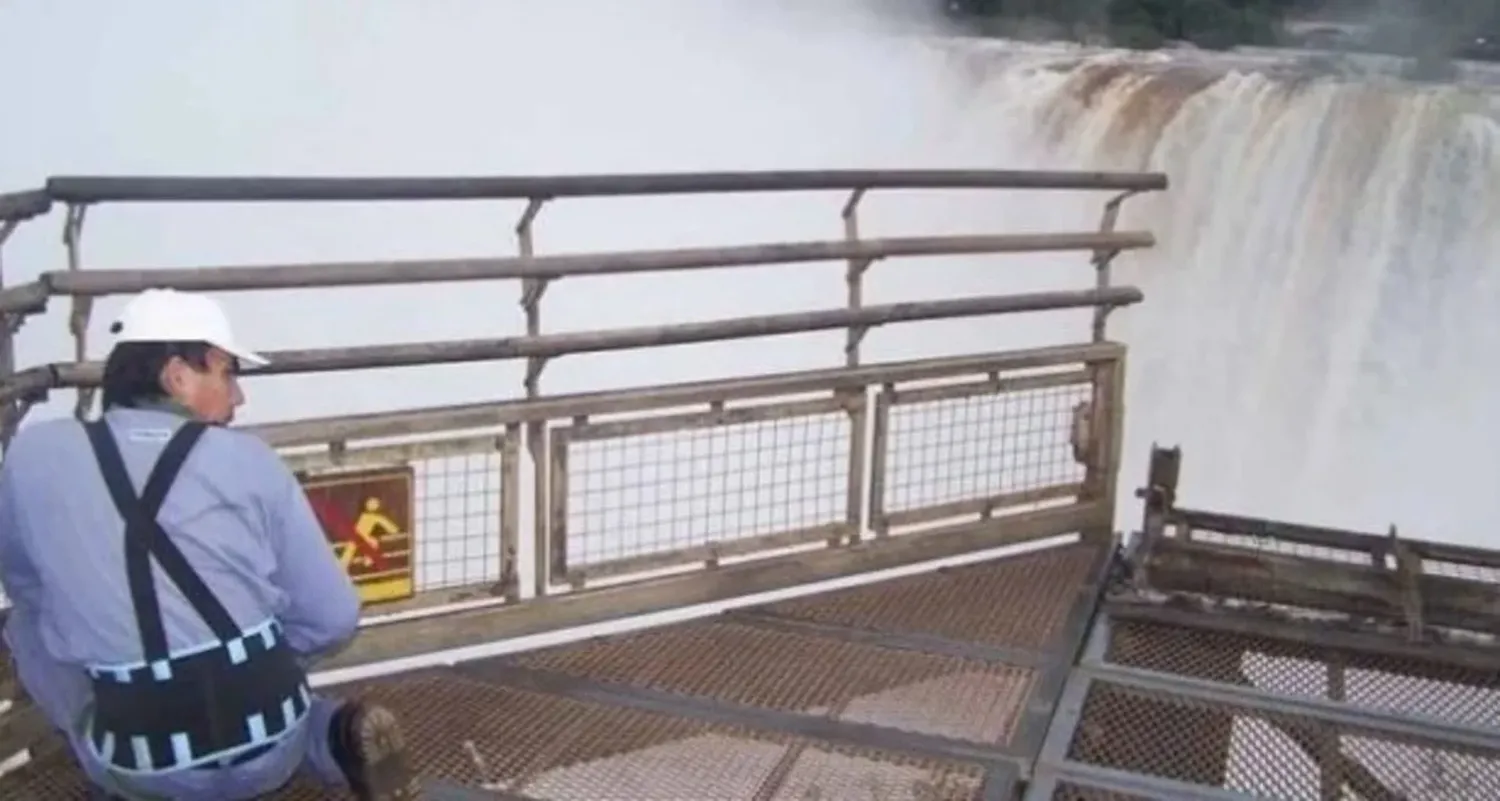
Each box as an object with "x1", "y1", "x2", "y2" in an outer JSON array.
[{"x1": 285, "y1": 432, "x2": 519, "y2": 609}]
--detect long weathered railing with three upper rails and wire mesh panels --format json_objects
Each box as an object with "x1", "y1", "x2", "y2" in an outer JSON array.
[{"x1": 0, "y1": 171, "x2": 1166, "y2": 653}]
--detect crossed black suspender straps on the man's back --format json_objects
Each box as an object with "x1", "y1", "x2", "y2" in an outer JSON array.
[{"x1": 84, "y1": 419, "x2": 240, "y2": 662}]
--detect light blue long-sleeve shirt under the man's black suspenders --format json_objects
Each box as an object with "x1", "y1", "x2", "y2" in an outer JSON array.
[{"x1": 0, "y1": 410, "x2": 360, "y2": 684}]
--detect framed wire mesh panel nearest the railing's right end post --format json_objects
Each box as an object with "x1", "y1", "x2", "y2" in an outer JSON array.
[{"x1": 870, "y1": 369, "x2": 1095, "y2": 536}]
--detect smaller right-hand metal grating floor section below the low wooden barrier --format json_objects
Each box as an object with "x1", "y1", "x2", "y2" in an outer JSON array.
[{"x1": 1041, "y1": 614, "x2": 1500, "y2": 801}]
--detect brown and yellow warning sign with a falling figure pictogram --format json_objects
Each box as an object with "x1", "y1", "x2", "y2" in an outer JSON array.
[{"x1": 302, "y1": 465, "x2": 416, "y2": 603}]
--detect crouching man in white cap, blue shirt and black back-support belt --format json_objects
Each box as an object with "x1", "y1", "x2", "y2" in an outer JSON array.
[{"x1": 0, "y1": 290, "x2": 417, "y2": 801}]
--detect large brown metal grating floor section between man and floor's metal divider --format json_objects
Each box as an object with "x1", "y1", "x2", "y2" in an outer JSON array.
[{"x1": 0, "y1": 545, "x2": 1104, "y2": 801}]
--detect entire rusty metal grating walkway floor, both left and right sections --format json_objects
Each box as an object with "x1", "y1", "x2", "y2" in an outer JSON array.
[{"x1": 11, "y1": 504, "x2": 1500, "y2": 801}]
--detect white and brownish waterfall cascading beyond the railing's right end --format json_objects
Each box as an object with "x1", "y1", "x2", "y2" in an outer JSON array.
[{"x1": 936, "y1": 48, "x2": 1500, "y2": 546}]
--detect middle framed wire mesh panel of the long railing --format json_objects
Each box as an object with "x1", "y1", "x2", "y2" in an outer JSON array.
[{"x1": 551, "y1": 395, "x2": 866, "y2": 584}]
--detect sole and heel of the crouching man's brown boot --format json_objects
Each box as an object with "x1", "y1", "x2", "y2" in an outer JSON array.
[{"x1": 329, "y1": 701, "x2": 422, "y2": 801}]
